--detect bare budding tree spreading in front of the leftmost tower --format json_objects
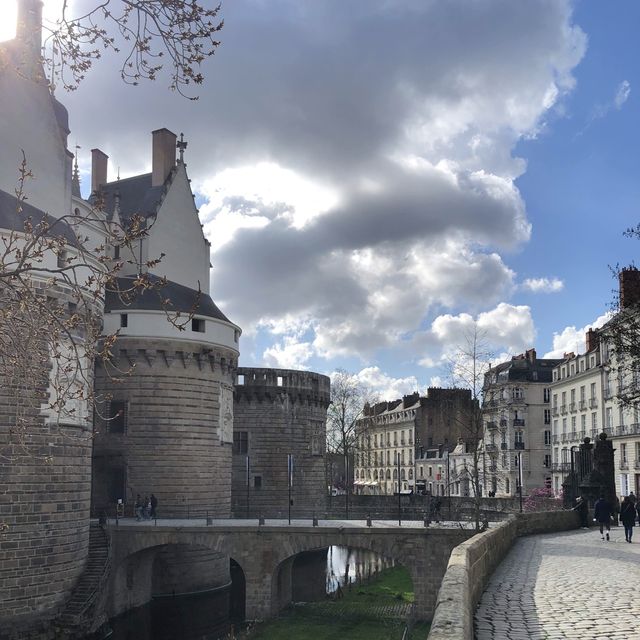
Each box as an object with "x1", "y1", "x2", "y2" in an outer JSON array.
[{"x1": 0, "y1": 156, "x2": 190, "y2": 461}]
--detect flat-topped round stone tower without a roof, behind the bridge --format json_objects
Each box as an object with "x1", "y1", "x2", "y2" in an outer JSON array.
[{"x1": 232, "y1": 367, "x2": 330, "y2": 517}]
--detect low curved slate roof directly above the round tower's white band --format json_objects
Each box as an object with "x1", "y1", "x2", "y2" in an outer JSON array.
[{"x1": 105, "y1": 276, "x2": 229, "y2": 322}]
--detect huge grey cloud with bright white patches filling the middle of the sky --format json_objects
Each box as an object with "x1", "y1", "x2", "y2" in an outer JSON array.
[{"x1": 60, "y1": 0, "x2": 586, "y2": 366}]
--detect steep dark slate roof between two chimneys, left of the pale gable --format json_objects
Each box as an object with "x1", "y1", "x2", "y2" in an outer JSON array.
[{"x1": 100, "y1": 173, "x2": 164, "y2": 226}]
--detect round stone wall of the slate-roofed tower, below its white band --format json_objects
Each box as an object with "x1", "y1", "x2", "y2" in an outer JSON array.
[{"x1": 93, "y1": 337, "x2": 237, "y2": 517}]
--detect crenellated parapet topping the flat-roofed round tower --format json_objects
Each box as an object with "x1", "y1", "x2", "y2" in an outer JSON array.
[{"x1": 235, "y1": 367, "x2": 331, "y2": 408}]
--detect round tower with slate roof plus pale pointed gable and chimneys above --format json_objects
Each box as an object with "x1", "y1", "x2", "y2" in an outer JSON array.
[{"x1": 92, "y1": 129, "x2": 240, "y2": 517}]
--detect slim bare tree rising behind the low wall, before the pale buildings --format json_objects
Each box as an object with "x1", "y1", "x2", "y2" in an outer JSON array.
[{"x1": 447, "y1": 324, "x2": 493, "y2": 531}]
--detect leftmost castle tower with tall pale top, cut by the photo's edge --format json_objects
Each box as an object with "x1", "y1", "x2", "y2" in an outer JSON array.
[{"x1": 0, "y1": 0, "x2": 97, "y2": 638}]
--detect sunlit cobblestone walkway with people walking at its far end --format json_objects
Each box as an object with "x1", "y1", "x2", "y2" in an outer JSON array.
[{"x1": 475, "y1": 527, "x2": 640, "y2": 640}]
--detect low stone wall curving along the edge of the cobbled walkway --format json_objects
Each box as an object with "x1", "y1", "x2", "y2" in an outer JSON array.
[{"x1": 428, "y1": 511, "x2": 579, "y2": 640}]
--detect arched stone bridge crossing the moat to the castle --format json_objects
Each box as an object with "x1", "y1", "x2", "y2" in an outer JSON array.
[{"x1": 109, "y1": 520, "x2": 473, "y2": 620}]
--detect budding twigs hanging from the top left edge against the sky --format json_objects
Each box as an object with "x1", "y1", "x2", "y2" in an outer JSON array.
[{"x1": 23, "y1": 0, "x2": 223, "y2": 99}]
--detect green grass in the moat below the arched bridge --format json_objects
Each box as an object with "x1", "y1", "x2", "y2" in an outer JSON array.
[{"x1": 241, "y1": 567, "x2": 429, "y2": 640}]
